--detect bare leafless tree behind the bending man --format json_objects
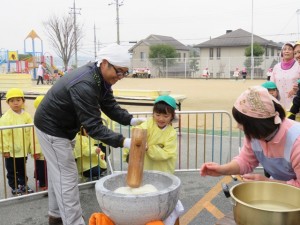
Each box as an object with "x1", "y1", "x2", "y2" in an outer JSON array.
[{"x1": 44, "y1": 15, "x2": 83, "y2": 68}]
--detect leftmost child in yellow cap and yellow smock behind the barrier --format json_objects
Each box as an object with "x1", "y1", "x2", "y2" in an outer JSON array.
[{"x1": 0, "y1": 88, "x2": 34, "y2": 195}]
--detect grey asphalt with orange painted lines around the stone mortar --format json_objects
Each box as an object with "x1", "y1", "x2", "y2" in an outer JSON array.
[{"x1": 0, "y1": 171, "x2": 239, "y2": 225}]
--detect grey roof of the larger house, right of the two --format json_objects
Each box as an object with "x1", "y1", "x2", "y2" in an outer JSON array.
[{"x1": 195, "y1": 29, "x2": 280, "y2": 48}]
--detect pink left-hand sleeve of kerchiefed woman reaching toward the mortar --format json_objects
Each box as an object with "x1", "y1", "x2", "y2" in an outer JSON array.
[{"x1": 233, "y1": 138, "x2": 259, "y2": 175}]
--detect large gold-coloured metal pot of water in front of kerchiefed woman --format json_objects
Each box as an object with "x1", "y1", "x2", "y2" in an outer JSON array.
[{"x1": 223, "y1": 181, "x2": 300, "y2": 225}]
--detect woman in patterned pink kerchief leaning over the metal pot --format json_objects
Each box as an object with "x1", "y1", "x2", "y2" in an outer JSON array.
[{"x1": 200, "y1": 86, "x2": 300, "y2": 187}]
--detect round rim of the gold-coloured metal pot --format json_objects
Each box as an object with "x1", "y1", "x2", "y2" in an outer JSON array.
[{"x1": 229, "y1": 181, "x2": 300, "y2": 213}]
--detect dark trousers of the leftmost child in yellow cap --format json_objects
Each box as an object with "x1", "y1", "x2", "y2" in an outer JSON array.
[{"x1": 5, "y1": 157, "x2": 27, "y2": 189}]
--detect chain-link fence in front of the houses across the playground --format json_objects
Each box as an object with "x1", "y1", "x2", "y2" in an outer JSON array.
[{"x1": 130, "y1": 56, "x2": 280, "y2": 79}]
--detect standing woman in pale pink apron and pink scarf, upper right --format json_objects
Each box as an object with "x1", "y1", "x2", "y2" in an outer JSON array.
[{"x1": 270, "y1": 43, "x2": 300, "y2": 110}]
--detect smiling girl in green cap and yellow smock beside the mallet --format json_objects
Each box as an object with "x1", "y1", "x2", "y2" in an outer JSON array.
[{"x1": 123, "y1": 95, "x2": 177, "y2": 173}]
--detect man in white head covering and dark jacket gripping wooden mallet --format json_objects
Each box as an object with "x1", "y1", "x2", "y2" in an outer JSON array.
[{"x1": 34, "y1": 44, "x2": 145, "y2": 225}]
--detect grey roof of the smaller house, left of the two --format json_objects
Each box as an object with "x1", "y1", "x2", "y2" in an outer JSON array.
[{"x1": 129, "y1": 34, "x2": 189, "y2": 52}]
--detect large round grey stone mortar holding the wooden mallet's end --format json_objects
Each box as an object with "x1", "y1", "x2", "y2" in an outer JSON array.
[{"x1": 95, "y1": 171, "x2": 181, "y2": 225}]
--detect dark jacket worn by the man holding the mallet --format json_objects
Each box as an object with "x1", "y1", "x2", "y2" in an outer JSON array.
[{"x1": 34, "y1": 63, "x2": 132, "y2": 147}]
